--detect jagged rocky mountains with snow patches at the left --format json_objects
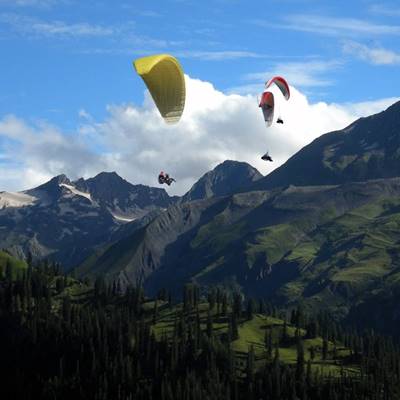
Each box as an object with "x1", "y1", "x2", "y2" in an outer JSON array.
[{"x1": 0, "y1": 172, "x2": 176, "y2": 267}]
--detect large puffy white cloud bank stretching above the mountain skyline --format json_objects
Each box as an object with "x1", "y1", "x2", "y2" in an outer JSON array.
[{"x1": 0, "y1": 76, "x2": 397, "y2": 194}]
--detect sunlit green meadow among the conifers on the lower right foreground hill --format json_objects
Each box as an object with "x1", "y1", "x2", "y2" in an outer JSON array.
[{"x1": 151, "y1": 301, "x2": 360, "y2": 376}]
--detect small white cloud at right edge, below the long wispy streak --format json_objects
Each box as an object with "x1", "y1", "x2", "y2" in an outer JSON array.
[{"x1": 343, "y1": 41, "x2": 400, "y2": 65}]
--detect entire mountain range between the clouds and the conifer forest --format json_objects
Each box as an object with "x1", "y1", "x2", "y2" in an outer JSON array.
[{"x1": 0, "y1": 102, "x2": 400, "y2": 330}]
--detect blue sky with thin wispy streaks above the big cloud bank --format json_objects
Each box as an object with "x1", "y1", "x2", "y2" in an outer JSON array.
[{"x1": 0, "y1": 0, "x2": 400, "y2": 194}]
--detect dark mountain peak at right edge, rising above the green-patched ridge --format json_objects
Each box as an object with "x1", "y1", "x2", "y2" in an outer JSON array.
[{"x1": 253, "y1": 102, "x2": 400, "y2": 190}]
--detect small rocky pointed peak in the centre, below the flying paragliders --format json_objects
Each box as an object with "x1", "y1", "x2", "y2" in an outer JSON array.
[{"x1": 181, "y1": 160, "x2": 263, "y2": 202}]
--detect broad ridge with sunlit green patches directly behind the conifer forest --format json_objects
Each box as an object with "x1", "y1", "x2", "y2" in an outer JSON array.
[{"x1": 81, "y1": 179, "x2": 400, "y2": 324}]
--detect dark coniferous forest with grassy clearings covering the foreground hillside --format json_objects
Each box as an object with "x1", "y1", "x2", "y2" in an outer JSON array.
[{"x1": 0, "y1": 261, "x2": 400, "y2": 400}]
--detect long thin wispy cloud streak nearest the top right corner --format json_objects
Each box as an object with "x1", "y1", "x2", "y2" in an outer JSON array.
[{"x1": 266, "y1": 14, "x2": 400, "y2": 36}]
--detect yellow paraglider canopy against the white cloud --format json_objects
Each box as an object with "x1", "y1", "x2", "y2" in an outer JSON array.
[{"x1": 133, "y1": 54, "x2": 186, "y2": 124}]
